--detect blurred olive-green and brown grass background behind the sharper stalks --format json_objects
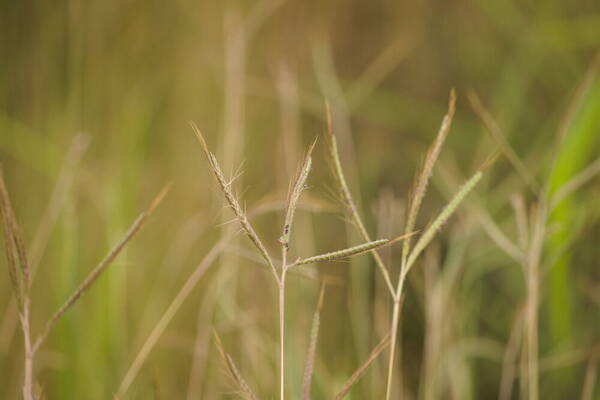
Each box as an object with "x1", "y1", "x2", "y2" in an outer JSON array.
[{"x1": 0, "y1": 0, "x2": 600, "y2": 399}]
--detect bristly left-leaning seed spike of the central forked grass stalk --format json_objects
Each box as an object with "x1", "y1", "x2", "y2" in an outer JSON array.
[{"x1": 190, "y1": 123, "x2": 279, "y2": 282}]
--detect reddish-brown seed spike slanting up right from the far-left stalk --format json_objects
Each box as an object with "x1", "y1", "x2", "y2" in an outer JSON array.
[{"x1": 33, "y1": 185, "x2": 170, "y2": 353}]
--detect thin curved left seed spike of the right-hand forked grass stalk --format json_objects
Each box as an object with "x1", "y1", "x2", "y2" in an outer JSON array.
[{"x1": 325, "y1": 102, "x2": 394, "y2": 296}]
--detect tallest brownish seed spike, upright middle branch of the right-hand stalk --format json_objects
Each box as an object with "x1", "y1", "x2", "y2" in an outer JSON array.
[{"x1": 402, "y1": 89, "x2": 456, "y2": 267}]
